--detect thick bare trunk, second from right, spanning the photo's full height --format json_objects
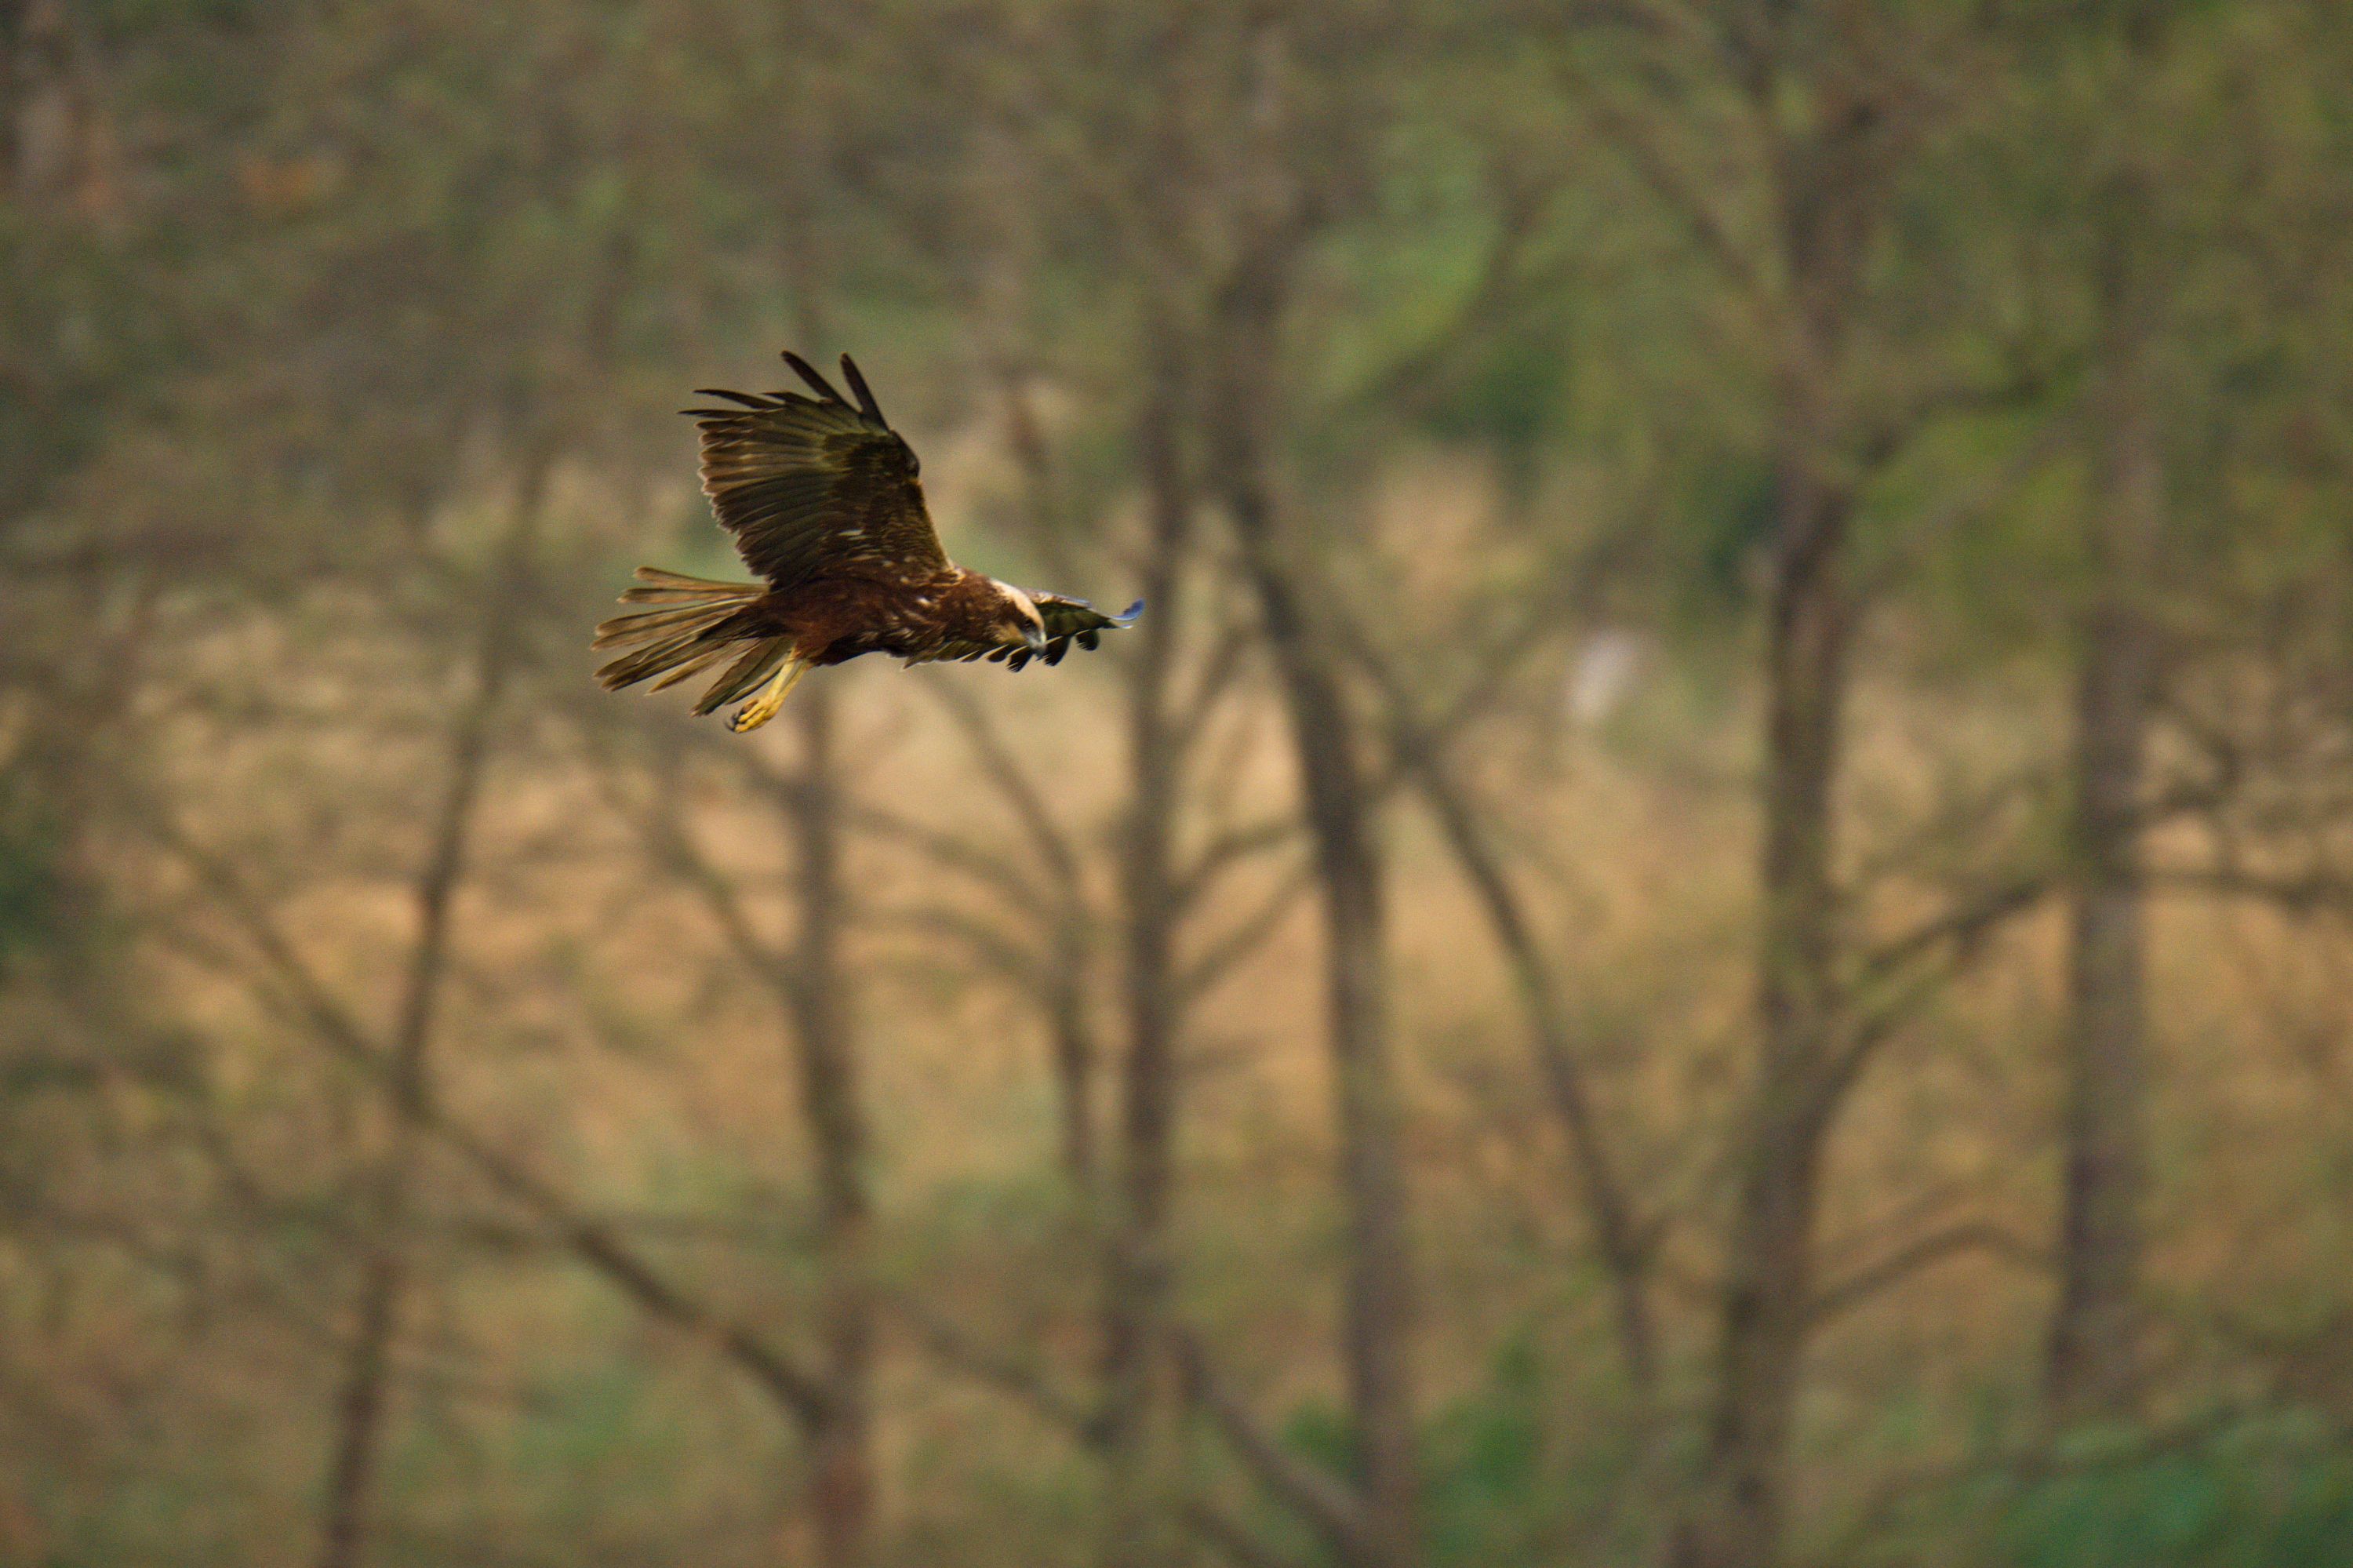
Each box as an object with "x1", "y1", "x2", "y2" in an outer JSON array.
[{"x1": 1673, "y1": 12, "x2": 1901, "y2": 1534}]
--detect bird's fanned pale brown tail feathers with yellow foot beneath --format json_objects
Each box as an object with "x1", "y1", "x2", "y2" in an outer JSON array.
[{"x1": 593, "y1": 567, "x2": 805, "y2": 729}]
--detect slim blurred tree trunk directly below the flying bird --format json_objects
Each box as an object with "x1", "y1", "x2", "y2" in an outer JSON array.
[{"x1": 791, "y1": 682, "x2": 875, "y2": 1568}]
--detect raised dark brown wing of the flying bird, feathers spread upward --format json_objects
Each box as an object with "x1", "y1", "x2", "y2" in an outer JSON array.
[{"x1": 685, "y1": 353, "x2": 948, "y2": 588}]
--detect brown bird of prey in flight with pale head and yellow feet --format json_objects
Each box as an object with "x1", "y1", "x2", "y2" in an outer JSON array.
[{"x1": 595, "y1": 353, "x2": 1144, "y2": 734}]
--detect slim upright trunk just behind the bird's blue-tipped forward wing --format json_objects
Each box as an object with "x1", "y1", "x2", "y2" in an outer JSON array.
[{"x1": 1104, "y1": 344, "x2": 1193, "y2": 1568}]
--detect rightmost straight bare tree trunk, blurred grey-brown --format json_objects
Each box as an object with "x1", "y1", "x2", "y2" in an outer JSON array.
[{"x1": 2049, "y1": 191, "x2": 2165, "y2": 1417}]
